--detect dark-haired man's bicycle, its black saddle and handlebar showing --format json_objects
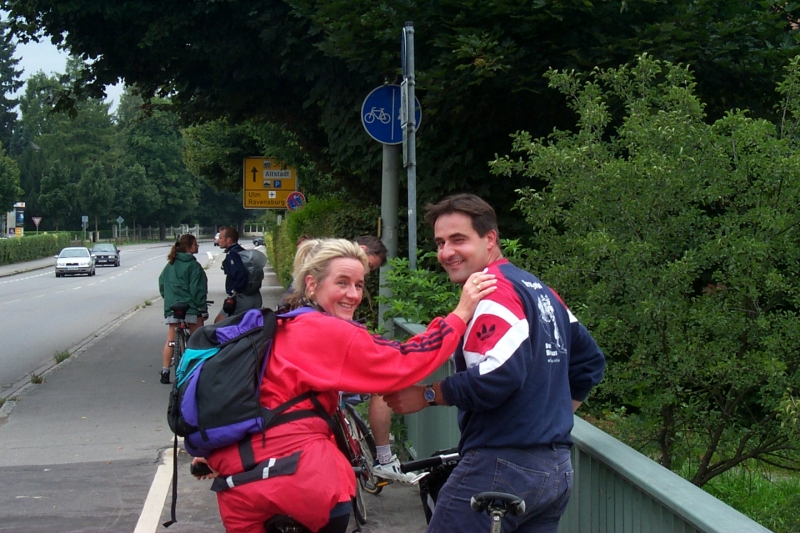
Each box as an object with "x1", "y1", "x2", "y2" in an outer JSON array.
[{"x1": 400, "y1": 449, "x2": 525, "y2": 533}]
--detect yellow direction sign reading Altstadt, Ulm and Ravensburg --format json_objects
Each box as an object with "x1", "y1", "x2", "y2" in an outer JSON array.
[{"x1": 242, "y1": 157, "x2": 297, "y2": 209}]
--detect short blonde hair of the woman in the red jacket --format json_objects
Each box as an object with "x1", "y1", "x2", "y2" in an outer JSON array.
[{"x1": 286, "y1": 239, "x2": 369, "y2": 309}]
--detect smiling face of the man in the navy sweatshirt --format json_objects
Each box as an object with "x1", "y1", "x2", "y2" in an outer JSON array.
[{"x1": 433, "y1": 213, "x2": 498, "y2": 285}]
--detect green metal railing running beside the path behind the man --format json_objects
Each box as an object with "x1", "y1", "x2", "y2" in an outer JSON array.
[{"x1": 394, "y1": 320, "x2": 769, "y2": 533}]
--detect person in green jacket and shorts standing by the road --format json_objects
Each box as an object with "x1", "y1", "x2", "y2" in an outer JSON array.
[{"x1": 158, "y1": 234, "x2": 208, "y2": 385}]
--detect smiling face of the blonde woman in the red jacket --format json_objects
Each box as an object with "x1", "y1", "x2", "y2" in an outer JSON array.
[{"x1": 306, "y1": 257, "x2": 364, "y2": 320}]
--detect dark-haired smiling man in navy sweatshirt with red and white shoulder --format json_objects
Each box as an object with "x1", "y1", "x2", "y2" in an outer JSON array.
[{"x1": 385, "y1": 194, "x2": 605, "y2": 533}]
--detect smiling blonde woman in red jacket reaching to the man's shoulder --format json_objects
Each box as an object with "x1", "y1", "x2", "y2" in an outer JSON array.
[{"x1": 196, "y1": 239, "x2": 495, "y2": 533}]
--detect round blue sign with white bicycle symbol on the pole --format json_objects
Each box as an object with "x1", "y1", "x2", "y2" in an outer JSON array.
[{"x1": 361, "y1": 85, "x2": 422, "y2": 144}]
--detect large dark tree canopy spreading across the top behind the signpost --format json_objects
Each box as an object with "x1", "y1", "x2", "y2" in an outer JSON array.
[{"x1": 0, "y1": 0, "x2": 798, "y2": 232}]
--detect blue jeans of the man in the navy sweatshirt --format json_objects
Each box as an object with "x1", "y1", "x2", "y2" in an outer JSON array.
[{"x1": 427, "y1": 445, "x2": 573, "y2": 533}]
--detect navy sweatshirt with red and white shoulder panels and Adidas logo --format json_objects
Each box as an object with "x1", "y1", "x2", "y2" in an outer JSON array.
[{"x1": 442, "y1": 259, "x2": 605, "y2": 454}]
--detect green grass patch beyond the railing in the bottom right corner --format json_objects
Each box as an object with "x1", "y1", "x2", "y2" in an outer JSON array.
[{"x1": 703, "y1": 468, "x2": 800, "y2": 533}]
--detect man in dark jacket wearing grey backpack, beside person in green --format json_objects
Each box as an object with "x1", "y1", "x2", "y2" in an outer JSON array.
[{"x1": 214, "y1": 226, "x2": 267, "y2": 323}]
